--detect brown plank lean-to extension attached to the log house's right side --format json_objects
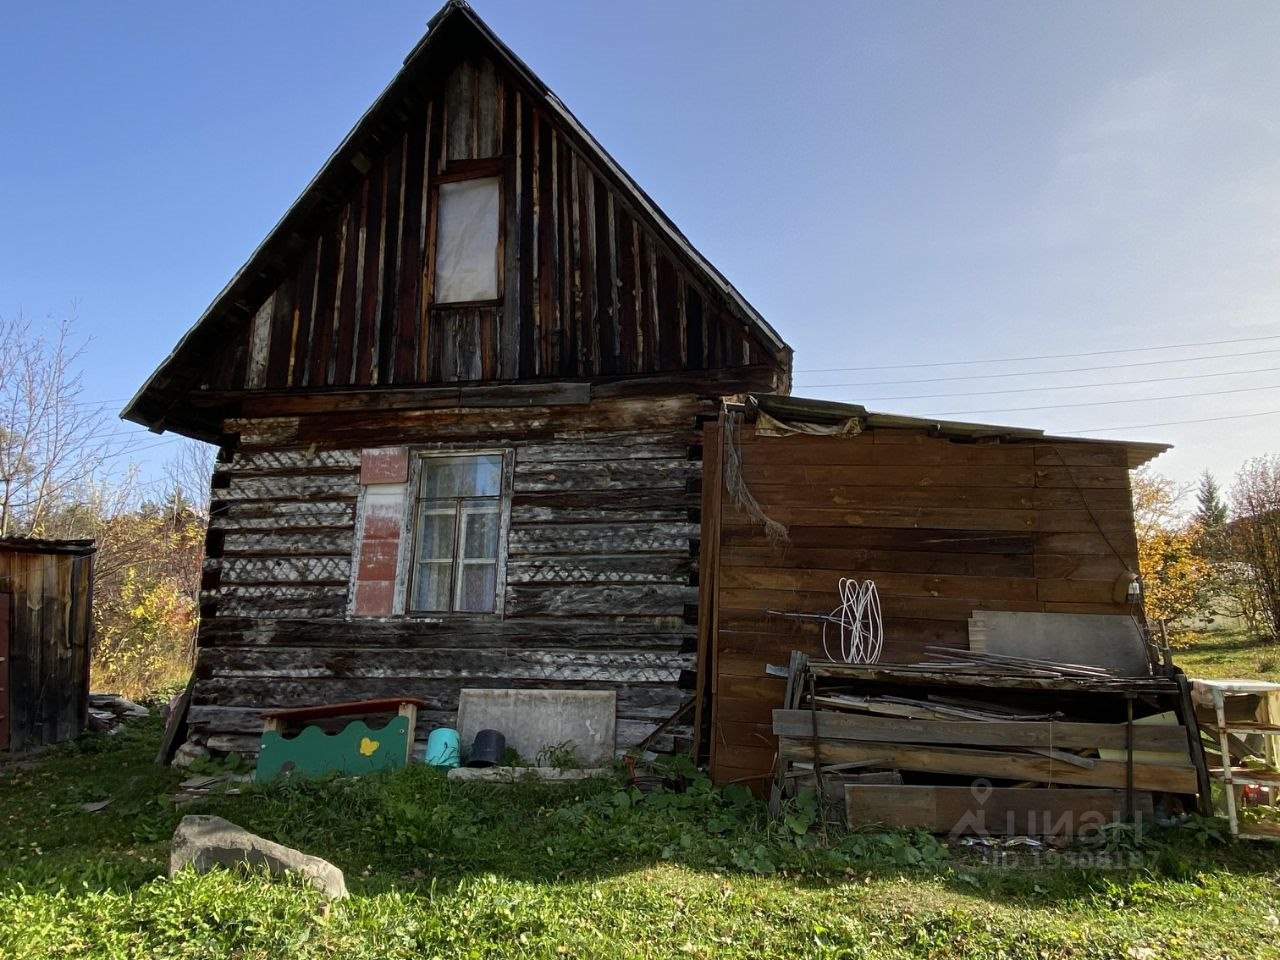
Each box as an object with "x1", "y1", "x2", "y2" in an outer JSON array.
[{"x1": 699, "y1": 396, "x2": 1167, "y2": 782}]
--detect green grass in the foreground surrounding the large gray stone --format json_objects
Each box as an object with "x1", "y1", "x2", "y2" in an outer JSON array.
[{"x1": 0, "y1": 722, "x2": 1280, "y2": 960}]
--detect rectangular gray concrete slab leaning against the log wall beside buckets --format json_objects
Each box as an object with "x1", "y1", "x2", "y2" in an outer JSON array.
[{"x1": 458, "y1": 689, "x2": 617, "y2": 767}]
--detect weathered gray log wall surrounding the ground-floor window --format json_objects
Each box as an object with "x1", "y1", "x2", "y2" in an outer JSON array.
[{"x1": 191, "y1": 396, "x2": 716, "y2": 746}]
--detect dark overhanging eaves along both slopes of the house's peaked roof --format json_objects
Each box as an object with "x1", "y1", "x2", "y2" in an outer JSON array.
[{"x1": 120, "y1": 0, "x2": 791, "y2": 440}]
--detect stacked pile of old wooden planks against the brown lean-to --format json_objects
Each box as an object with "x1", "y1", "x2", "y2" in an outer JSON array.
[{"x1": 773, "y1": 652, "x2": 1207, "y2": 836}]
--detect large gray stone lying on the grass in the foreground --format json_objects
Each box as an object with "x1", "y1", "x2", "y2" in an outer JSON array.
[{"x1": 169, "y1": 815, "x2": 347, "y2": 900}]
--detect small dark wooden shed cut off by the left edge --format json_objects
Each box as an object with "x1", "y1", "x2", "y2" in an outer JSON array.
[{"x1": 0, "y1": 538, "x2": 96, "y2": 753}]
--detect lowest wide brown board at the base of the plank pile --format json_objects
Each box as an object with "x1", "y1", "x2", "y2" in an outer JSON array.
[{"x1": 845, "y1": 783, "x2": 1152, "y2": 837}]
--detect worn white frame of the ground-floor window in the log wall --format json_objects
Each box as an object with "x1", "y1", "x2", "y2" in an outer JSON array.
[{"x1": 396, "y1": 447, "x2": 516, "y2": 620}]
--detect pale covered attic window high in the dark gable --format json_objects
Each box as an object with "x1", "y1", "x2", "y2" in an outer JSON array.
[{"x1": 434, "y1": 177, "x2": 500, "y2": 303}]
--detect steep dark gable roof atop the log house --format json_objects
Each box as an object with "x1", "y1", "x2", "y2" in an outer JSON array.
[{"x1": 120, "y1": 0, "x2": 791, "y2": 440}]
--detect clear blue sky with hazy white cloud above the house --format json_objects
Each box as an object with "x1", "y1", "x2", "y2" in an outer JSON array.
[{"x1": 0, "y1": 0, "x2": 1280, "y2": 504}]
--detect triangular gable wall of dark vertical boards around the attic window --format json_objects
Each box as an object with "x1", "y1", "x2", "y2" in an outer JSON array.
[{"x1": 200, "y1": 52, "x2": 788, "y2": 392}]
